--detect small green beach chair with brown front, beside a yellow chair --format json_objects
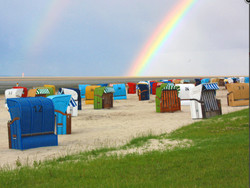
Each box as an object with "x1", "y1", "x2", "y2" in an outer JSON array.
[{"x1": 94, "y1": 87, "x2": 115, "y2": 109}]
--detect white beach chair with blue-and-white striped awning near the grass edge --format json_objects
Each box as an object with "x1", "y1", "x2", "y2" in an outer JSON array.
[{"x1": 189, "y1": 83, "x2": 222, "y2": 119}]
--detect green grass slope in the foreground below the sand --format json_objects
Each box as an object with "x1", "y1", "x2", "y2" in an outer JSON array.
[{"x1": 0, "y1": 109, "x2": 249, "y2": 188}]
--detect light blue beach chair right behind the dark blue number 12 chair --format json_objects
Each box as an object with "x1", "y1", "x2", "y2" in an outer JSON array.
[{"x1": 47, "y1": 95, "x2": 71, "y2": 134}]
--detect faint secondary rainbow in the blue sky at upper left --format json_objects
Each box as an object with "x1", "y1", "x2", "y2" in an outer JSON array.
[{"x1": 25, "y1": 0, "x2": 70, "y2": 56}]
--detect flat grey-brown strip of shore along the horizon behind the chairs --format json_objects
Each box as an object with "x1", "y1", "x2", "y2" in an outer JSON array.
[{"x1": 0, "y1": 76, "x2": 247, "y2": 94}]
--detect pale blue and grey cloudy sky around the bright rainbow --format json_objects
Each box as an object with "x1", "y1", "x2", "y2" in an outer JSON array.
[{"x1": 0, "y1": 0, "x2": 249, "y2": 76}]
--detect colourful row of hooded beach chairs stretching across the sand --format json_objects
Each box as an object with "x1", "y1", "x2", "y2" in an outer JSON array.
[{"x1": 5, "y1": 81, "x2": 249, "y2": 150}]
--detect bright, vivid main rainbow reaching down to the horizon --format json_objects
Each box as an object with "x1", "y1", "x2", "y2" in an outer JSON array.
[{"x1": 127, "y1": 0, "x2": 197, "y2": 76}]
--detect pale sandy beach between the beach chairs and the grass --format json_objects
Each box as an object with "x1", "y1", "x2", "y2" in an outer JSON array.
[{"x1": 0, "y1": 89, "x2": 248, "y2": 167}]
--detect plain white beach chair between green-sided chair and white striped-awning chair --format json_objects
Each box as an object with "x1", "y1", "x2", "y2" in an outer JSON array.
[{"x1": 176, "y1": 84, "x2": 195, "y2": 106}]
